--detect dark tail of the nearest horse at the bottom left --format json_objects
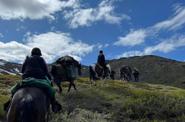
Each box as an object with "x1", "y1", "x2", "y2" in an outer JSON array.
[{"x1": 17, "y1": 95, "x2": 36, "y2": 122}]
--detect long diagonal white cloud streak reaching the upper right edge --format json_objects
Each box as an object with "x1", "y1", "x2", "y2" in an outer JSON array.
[{"x1": 114, "y1": 6, "x2": 185, "y2": 46}]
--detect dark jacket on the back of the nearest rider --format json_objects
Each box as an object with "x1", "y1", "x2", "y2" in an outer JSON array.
[{"x1": 21, "y1": 55, "x2": 51, "y2": 80}]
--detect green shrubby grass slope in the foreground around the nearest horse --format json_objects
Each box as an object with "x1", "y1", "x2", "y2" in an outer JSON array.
[{"x1": 0, "y1": 76, "x2": 185, "y2": 122}]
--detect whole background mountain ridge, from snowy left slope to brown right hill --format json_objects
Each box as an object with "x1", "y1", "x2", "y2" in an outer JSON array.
[{"x1": 0, "y1": 55, "x2": 185, "y2": 88}]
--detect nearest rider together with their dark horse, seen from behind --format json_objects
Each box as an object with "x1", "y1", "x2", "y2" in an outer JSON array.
[{"x1": 4, "y1": 48, "x2": 61, "y2": 122}]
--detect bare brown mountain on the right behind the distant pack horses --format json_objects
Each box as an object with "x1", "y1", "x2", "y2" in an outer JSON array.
[{"x1": 109, "y1": 55, "x2": 185, "y2": 88}]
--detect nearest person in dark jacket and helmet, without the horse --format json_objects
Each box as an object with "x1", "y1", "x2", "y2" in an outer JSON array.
[{"x1": 4, "y1": 48, "x2": 61, "y2": 112}]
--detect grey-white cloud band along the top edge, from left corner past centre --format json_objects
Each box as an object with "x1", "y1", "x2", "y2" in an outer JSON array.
[{"x1": 0, "y1": 0, "x2": 130, "y2": 28}]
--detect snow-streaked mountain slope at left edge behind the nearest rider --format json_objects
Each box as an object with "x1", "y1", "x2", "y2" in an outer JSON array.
[{"x1": 0, "y1": 59, "x2": 21, "y2": 75}]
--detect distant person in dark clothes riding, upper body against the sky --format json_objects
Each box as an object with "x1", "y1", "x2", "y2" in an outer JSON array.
[{"x1": 97, "y1": 50, "x2": 106, "y2": 75}]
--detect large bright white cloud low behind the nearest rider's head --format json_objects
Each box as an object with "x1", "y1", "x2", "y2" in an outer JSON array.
[{"x1": 0, "y1": 32, "x2": 94, "y2": 63}]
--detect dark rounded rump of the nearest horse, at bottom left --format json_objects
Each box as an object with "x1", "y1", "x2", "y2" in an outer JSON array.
[{"x1": 7, "y1": 87, "x2": 50, "y2": 122}]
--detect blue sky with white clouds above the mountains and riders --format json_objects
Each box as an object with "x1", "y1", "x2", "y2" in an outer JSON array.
[{"x1": 0, "y1": 0, "x2": 185, "y2": 65}]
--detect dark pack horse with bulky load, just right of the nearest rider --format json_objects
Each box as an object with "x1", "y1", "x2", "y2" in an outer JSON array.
[{"x1": 51, "y1": 56, "x2": 81, "y2": 93}]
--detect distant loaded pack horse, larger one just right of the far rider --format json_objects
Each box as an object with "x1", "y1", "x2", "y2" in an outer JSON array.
[{"x1": 120, "y1": 66, "x2": 132, "y2": 81}]
